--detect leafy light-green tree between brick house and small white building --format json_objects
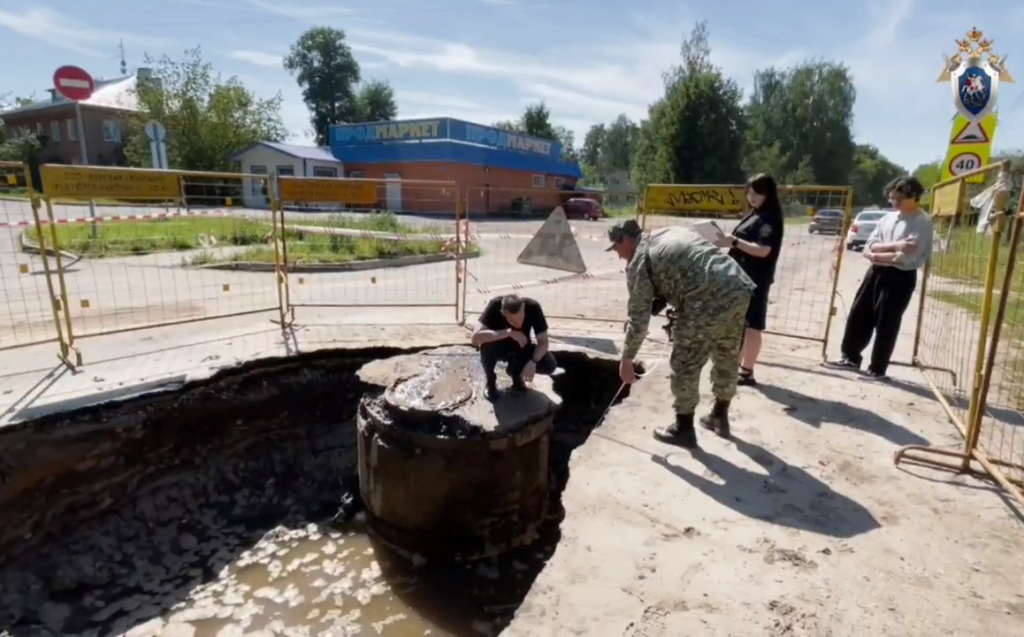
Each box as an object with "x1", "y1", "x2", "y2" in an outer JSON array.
[{"x1": 125, "y1": 48, "x2": 288, "y2": 171}]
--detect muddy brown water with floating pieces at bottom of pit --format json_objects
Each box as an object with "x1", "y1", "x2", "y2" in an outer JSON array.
[{"x1": 160, "y1": 515, "x2": 550, "y2": 637}]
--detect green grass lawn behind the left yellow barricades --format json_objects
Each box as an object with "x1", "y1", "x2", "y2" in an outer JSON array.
[{"x1": 28, "y1": 214, "x2": 468, "y2": 265}]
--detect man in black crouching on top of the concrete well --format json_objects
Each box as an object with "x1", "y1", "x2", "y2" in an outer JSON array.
[{"x1": 472, "y1": 294, "x2": 558, "y2": 400}]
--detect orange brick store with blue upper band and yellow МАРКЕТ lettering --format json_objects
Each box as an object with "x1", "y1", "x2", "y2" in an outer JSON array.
[{"x1": 330, "y1": 118, "x2": 583, "y2": 214}]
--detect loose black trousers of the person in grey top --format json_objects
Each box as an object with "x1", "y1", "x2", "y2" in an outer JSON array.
[{"x1": 842, "y1": 265, "x2": 918, "y2": 374}]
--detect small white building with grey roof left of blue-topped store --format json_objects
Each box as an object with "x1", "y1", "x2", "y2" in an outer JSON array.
[{"x1": 231, "y1": 141, "x2": 345, "y2": 208}]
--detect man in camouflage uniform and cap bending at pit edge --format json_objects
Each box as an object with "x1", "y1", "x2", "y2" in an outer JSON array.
[{"x1": 608, "y1": 219, "x2": 755, "y2": 448}]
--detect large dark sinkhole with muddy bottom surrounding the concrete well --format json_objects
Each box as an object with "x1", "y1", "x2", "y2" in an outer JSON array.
[{"x1": 0, "y1": 347, "x2": 628, "y2": 637}]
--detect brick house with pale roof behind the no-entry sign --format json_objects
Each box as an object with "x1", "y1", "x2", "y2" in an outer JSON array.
[{"x1": 0, "y1": 69, "x2": 152, "y2": 166}]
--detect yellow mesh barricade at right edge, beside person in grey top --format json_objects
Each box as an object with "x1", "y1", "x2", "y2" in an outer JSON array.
[{"x1": 895, "y1": 161, "x2": 1024, "y2": 514}]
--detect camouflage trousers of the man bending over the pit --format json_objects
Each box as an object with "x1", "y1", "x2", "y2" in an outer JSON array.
[{"x1": 669, "y1": 291, "x2": 751, "y2": 414}]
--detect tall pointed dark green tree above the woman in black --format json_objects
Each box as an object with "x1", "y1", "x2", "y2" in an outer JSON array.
[{"x1": 632, "y1": 23, "x2": 743, "y2": 187}]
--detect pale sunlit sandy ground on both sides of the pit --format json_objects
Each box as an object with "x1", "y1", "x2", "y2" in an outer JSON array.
[{"x1": 0, "y1": 206, "x2": 1024, "y2": 637}]
